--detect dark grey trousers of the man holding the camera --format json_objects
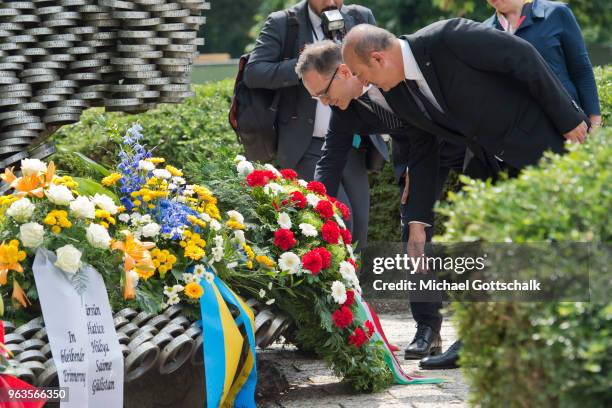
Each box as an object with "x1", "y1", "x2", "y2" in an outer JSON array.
[{"x1": 295, "y1": 137, "x2": 370, "y2": 251}]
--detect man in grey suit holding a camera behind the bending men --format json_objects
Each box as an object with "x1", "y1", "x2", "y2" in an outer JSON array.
[{"x1": 244, "y1": 0, "x2": 387, "y2": 252}]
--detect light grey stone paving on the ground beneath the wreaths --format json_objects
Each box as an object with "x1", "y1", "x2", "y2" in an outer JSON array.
[{"x1": 258, "y1": 313, "x2": 468, "y2": 408}]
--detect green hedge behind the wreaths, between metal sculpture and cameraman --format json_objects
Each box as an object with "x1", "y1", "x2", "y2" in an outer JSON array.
[{"x1": 52, "y1": 80, "x2": 241, "y2": 183}]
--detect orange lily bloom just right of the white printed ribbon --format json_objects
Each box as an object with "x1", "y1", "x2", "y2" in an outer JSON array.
[{"x1": 111, "y1": 231, "x2": 155, "y2": 299}]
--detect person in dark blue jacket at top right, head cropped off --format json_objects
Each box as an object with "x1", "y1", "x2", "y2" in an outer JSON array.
[{"x1": 484, "y1": 0, "x2": 601, "y2": 129}]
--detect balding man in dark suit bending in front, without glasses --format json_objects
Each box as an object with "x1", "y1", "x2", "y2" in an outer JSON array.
[{"x1": 343, "y1": 19, "x2": 588, "y2": 368}]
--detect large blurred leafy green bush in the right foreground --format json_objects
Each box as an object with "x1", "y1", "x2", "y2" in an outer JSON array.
[{"x1": 440, "y1": 126, "x2": 612, "y2": 407}]
